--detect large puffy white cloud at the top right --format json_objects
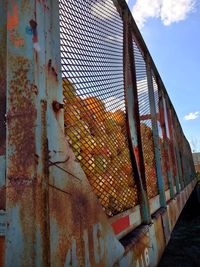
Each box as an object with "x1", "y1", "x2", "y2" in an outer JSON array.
[{"x1": 132, "y1": 0, "x2": 197, "y2": 28}]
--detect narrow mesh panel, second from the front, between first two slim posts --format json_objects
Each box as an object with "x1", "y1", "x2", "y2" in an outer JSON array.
[{"x1": 133, "y1": 41, "x2": 158, "y2": 198}]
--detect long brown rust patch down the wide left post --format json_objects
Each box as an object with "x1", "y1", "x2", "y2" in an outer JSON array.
[{"x1": 7, "y1": 57, "x2": 37, "y2": 196}]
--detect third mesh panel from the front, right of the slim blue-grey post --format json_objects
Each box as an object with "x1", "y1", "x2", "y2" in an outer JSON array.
[{"x1": 152, "y1": 76, "x2": 169, "y2": 190}]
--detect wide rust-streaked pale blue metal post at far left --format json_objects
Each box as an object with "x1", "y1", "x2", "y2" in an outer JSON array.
[{"x1": 5, "y1": 0, "x2": 62, "y2": 267}]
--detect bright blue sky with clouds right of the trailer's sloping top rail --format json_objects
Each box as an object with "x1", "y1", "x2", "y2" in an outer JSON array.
[{"x1": 127, "y1": 0, "x2": 200, "y2": 151}]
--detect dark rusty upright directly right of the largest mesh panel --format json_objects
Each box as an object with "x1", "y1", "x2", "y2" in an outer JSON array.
[{"x1": 123, "y1": 10, "x2": 151, "y2": 223}]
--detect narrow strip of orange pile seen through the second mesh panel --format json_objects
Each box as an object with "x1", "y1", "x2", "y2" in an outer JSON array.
[{"x1": 140, "y1": 123, "x2": 158, "y2": 199}]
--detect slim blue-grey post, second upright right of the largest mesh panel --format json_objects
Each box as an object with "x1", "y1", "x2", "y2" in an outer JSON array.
[{"x1": 146, "y1": 59, "x2": 166, "y2": 208}]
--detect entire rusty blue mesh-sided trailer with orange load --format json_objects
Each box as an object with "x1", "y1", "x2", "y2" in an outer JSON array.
[{"x1": 0, "y1": 0, "x2": 195, "y2": 267}]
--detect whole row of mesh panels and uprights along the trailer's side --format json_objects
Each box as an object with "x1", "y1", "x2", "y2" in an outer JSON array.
[{"x1": 59, "y1": 0, "x2": 193, "y2": 222}]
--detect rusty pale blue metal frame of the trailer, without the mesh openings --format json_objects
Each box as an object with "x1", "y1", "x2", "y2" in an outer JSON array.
[{"x1": 0, "y1": 0, "x2": 195, "y2": 267}]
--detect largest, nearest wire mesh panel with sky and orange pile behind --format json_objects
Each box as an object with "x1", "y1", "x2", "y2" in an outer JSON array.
[{"x1": 59, "y1": 0, "x2": 138, "y2": 216}]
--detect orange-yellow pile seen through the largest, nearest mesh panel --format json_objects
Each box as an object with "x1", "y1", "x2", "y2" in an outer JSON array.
[{"x1": 63, "y1": 79, "x2": 137, "y2": 216}]
